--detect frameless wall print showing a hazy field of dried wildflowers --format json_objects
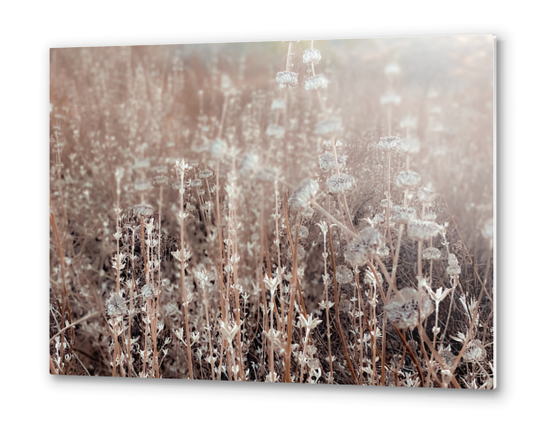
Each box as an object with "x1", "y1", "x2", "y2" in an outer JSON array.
[{"x1": 49, "y1": 36, "x2": 495, "y2": 389}]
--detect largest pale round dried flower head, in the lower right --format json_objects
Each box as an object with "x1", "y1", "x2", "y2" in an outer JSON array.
[{"x1": 384, "y1": 287, "x2": 434, "y2": 330}]
